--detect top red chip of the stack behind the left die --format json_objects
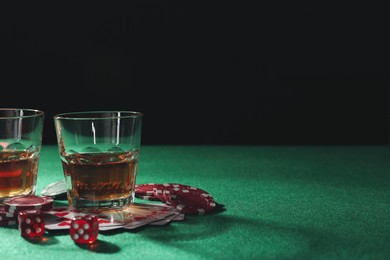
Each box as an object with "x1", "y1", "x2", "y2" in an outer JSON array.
[{"x1": 4, "y1": 195, "x2": 54, "y2": 214}]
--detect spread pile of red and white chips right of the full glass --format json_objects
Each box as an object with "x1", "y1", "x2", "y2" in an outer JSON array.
[{"x1": 136, "y1": 183, "x2": 216, "y2": 215}]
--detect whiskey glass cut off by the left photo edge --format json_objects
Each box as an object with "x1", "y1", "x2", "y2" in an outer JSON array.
[{"x1": 0, "y1": 108, "x2": 44, "y2": 204}]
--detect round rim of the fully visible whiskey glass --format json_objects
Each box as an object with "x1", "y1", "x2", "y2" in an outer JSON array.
[{"x1": 53, "y1": 110, "x2": 144, "y2": 121}]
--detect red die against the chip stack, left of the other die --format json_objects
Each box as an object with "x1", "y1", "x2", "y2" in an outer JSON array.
[{"x1": 18, "y1": 209, "x2": 45, "y2": 238}]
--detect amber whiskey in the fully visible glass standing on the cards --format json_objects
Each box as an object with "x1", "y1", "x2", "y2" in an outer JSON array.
[{"x1": 62, "y1": 151, "x2": 138, "y2": 210}]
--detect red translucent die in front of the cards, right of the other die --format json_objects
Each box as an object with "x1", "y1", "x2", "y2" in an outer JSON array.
[{"x1": 69, "y1": 215, "x2": 99, "y2": 244}]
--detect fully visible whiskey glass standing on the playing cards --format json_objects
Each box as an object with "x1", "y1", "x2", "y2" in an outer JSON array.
[{"x1": 54, "y1": 111, "x2": 143, "y2": 212}]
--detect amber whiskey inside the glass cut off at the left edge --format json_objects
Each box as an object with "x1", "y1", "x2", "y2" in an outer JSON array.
[{"x1": 0, "y1": 150, "x2": 39, "y2": 202}]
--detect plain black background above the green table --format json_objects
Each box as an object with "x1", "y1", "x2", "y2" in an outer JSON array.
[{"x1": 0, "y1": 2, "x2": 390, "y2": 145}]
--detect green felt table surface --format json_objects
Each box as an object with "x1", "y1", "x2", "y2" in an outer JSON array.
[{"x1": 0, "y1": 145, "x2": 390, "y2": 260}]
